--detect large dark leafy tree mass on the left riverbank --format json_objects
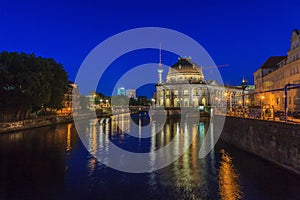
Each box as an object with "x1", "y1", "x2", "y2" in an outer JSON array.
[{"x1": 0, "y1": 51, "x2": 68, "y2": 119}]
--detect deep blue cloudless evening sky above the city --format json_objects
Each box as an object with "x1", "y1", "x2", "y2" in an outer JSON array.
[{"x1": 0, "y1": 0, "x2": 300, "y2": 97}]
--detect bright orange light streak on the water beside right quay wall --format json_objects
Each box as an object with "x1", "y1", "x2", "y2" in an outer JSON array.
[{"x1": 219, "y1": 149, "x2": 242, "y2": 200}]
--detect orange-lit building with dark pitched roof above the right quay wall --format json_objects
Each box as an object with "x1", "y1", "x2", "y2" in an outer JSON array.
[{"x1": 254, "y1": 30, "x2": 300, "y2": 111}]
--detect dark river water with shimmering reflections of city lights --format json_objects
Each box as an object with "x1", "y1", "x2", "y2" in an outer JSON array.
[{"x1": 0, "y1": 113, "x2": 300, "y2": 200}]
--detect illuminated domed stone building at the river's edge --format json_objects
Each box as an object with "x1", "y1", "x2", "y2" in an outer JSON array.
[{"x1": 156, "y1": 57, "x2": 246, "y2": 111}]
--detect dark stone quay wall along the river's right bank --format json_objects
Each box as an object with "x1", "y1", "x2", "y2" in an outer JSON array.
[{"x1": 215, "y1": 116, "x2": 300, "y2": 174}]
